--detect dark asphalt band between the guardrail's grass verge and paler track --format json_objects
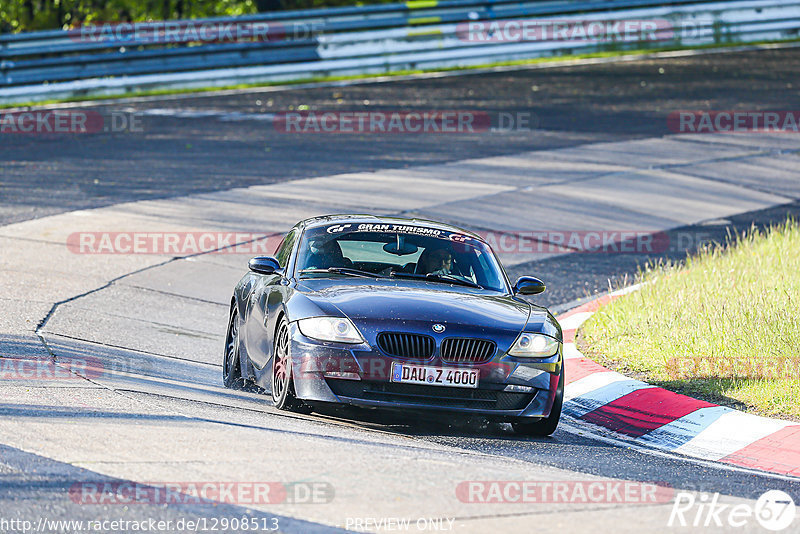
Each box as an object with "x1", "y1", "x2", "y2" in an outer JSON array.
[{"x1": 0, "y1": 48, "x2": 800, "y2": 228}]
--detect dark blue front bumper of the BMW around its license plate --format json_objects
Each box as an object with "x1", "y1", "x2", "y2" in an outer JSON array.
[{"x1": 291, "y1": 324, "x2": 563, "y2": 418}]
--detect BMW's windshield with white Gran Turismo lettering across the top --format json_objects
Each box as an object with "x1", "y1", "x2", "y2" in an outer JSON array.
[{"x1": 297, "y1": 223, "x2": 507, "y2": 291}]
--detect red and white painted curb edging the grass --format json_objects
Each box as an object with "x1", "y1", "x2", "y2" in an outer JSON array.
[{"x1": 558, "y1": 287, "x2": 800, "y2": 482}]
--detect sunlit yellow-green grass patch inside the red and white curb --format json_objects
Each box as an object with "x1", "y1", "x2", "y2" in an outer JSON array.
[{"x1": 578, "y1": 221, "x2": 800, "y2": 420}]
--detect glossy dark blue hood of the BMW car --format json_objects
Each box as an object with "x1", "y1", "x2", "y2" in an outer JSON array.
[{"x1": 297, "y1": 278, "x2": 532, "y2": 335}]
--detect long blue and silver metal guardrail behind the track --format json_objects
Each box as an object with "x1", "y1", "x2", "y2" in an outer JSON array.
[{"x1": 0, "y1": 0, "x2": 800, "y2": 103}]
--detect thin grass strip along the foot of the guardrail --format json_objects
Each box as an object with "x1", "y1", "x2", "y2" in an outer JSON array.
[{"x1": 0, "y1": 39, "x2": 800, "y2": 109}]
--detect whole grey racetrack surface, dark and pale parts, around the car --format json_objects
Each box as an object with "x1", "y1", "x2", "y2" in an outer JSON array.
[{"x1": 0, "y1": 49, "x2": 800, "y2": 532}]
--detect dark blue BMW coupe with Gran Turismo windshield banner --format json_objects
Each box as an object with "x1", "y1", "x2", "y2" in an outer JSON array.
[{"x1": 223, "y1": 215, "x2": 564, "y2": 436}]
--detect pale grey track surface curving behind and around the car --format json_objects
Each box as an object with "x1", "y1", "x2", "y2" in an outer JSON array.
[{"x1": 0, "y1": 134, "x2": 800, "y2": 531}]
